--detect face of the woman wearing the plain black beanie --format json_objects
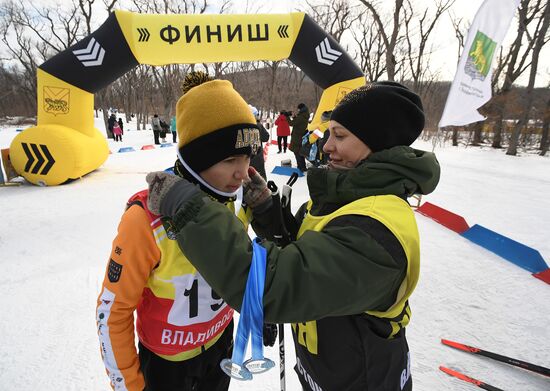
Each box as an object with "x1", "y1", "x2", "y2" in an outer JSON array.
[{"x1": 323, "y1": 121, "x2": 372, "y2": 170}]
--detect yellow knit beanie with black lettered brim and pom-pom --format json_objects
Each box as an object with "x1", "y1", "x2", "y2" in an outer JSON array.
[{"x1": 176, "y1": 72, "x2": 260, "y2": 173}]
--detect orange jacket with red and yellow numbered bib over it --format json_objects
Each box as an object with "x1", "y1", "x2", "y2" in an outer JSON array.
[{"x1": 96, "y1": 190, "x2": 250, "y2": 391}]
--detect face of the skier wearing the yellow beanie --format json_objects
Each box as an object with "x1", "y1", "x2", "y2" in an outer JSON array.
[{"x1": 200, "y1": 155, "x2": 250, "y2": 193}]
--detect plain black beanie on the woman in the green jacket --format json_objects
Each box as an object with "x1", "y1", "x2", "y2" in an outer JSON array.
[{"x1": 330, "y1": 81, "x2": 424, "y2": 152}]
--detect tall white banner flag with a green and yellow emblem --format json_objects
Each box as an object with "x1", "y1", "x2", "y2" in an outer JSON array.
[{"x1": 439, "y1": 0, "x2": 520, "y2": 128}]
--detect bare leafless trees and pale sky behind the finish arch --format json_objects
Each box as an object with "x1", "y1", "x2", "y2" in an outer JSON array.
[{"x1": 0, "y1": 0, "x2": 550, "y2": 155}]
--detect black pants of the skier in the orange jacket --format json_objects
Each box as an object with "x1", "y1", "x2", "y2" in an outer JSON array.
[{"x1": 139, "y1": 322, "x2": 233, "y2": 391}]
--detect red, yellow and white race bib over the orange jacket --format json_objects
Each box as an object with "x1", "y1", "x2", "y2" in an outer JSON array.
[{"x1": 130, "y1": 191, "x2": 251, "y2": 361}]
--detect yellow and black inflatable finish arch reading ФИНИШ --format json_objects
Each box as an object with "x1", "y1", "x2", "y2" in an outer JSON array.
[{"x1": 10, "y1": 11, "x2": 364, "y2": 186}]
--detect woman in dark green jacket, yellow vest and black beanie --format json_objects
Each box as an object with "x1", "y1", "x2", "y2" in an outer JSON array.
[{"x1": 147, "y1": 82, "x2": 440, "y2": 391}]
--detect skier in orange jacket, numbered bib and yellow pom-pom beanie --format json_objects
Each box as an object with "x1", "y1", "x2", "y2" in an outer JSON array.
[{"x1": 96, "y1": 72, "x2": 273, "y2": 391}]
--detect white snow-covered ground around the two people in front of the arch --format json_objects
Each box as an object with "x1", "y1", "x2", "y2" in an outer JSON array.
[{"x1": 0, "y1": 120, "x2": 550, "y2": 391}]
